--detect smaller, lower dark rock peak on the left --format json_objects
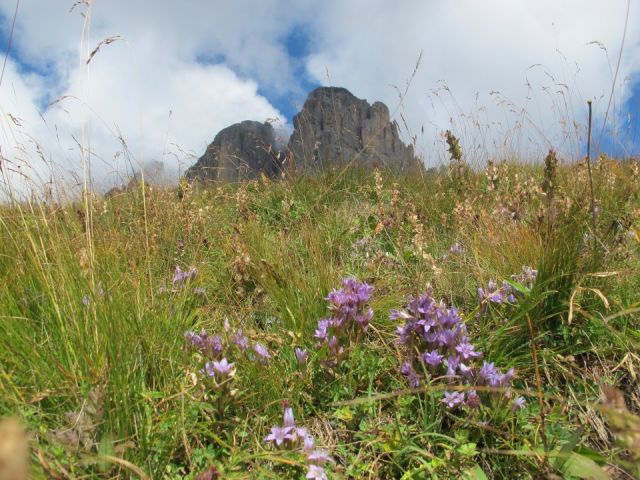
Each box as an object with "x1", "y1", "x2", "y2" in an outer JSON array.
[{"x1": 186, "y1": 120, "x2": 278, "y2": 182}]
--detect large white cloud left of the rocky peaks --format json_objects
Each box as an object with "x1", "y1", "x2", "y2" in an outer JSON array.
[{"x1": 0, "y1": 0, "x2": 298, "y2": 195}]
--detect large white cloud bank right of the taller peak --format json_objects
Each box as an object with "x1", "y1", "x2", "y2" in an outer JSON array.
[{"x1": 308, "y1": 0, "x2": 640, "y2": 163}]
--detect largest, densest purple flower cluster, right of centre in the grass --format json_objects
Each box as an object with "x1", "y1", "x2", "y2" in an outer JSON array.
[{"x1": 391, "y1": 290, "x2": 514, "y2": 409}]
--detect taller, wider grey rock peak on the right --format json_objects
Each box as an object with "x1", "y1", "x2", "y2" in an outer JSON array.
[{"x1": 289, "y1": 87, "x2": 416, "y2": 171}]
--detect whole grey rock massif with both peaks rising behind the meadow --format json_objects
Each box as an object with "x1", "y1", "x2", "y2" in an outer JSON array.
[{"x1": 186, "y1": 87, "x2": 418, "y2": 182}]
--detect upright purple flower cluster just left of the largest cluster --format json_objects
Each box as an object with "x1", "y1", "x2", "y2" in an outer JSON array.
[{"x1": 314, "y1": 278, "x2": 373, "y2": 366}]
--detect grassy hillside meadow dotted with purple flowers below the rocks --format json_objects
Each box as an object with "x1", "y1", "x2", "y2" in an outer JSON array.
[{"x1": 0, "y1": 157, "x2": 640, "y2": 479}]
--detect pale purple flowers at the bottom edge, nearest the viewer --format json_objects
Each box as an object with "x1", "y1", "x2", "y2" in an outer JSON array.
[{"x1": 264, "y1": 405, "x2": 334, "y2": 480}]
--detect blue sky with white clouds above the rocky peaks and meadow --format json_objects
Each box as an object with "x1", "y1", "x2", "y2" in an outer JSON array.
[{"x1": 0, "y1": 0, "x2": 640, "y2": 196}]
